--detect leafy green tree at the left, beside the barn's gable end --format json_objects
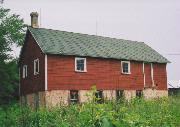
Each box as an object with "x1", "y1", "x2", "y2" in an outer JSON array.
[{"x1": 0, "y1": 7, "x2": 26, "y2": 104}]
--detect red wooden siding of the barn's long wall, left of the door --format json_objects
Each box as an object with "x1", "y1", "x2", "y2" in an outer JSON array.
[{"x1": 48, "y1": 55, "x2": 144, "y2": 90}]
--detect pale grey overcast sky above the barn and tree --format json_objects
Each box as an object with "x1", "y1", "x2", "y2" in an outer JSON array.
[{"x1": 1, "y1": 0, "x2": 180, "y2": 80}]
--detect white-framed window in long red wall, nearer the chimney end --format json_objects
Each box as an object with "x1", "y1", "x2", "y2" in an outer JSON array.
[{"x1": 75, "y1": 58, "x2": 87, "y2": 72}]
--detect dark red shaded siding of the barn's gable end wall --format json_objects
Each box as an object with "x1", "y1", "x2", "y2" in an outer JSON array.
[{"x1": 20, "y1": 33, "x2": 45, "y2": 95}]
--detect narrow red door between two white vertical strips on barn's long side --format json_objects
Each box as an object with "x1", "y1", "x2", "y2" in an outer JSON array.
[{"x1": 144, "y1": 63, "x2": 152, "y2": 88}]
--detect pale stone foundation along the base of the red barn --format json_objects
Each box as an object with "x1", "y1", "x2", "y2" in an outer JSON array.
[{"x1": 20, "y1": 88, "x2": 168, "y2": 108}]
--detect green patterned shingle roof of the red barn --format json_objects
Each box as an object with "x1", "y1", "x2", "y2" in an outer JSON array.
[{"x1": 28, "y1": 27, "x2": 169, "y2": 63}]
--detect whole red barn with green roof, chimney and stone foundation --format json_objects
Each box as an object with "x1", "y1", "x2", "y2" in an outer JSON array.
[{"x1": 19, "y1": 13, "x2": 169, "y2": 106}]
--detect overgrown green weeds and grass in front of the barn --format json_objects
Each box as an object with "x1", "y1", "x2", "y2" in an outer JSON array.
[{"x1": 0, "y1": 97, "x2": 180, "y2": 127}]
